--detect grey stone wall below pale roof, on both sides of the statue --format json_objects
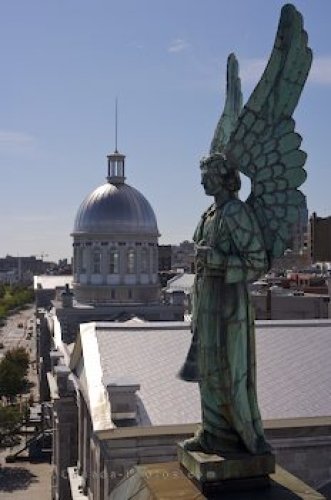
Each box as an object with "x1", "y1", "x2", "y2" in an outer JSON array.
[{"x1": 70, "y1": 426, "x2": 331, "y2": 500}]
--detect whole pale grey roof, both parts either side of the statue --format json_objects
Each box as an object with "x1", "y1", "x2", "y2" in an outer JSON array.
[{"x1": 95, "y1": 320, "x2": 331, "y2": 426}]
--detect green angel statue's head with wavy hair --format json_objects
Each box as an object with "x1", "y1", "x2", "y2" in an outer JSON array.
[{"x1": 200, "y1": 153, "x2": 241, "y2": 196}]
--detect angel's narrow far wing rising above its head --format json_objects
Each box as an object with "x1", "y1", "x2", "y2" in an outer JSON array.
[{"x1": 210, "y1": 54, "x2": 242, "y2": 154}]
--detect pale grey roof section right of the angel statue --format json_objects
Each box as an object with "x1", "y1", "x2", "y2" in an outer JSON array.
[{"x1": 256, "y1": 320, "x2": 331, "y2": 419}]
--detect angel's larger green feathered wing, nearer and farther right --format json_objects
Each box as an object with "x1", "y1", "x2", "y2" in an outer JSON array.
[{"x1": 224, "y1": 5, "x2": 312, "y2": 261}]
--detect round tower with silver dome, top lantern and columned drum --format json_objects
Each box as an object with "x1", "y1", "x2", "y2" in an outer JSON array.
[{"x1": 72, "y1": 152, "x2": 160, "y2": 304}]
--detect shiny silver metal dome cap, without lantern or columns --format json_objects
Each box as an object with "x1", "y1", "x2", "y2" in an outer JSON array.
[{"x1": 73, "y1": 182, "x2": 159, "y2": 236}]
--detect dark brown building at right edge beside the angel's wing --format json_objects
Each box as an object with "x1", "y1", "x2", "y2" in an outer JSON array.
[{"x1": 309, "y1": 212, "x2": 331, "y2": 263}]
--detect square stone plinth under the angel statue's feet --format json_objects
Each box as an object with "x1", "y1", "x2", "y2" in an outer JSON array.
[{"x1": 177, "y1": 443, "x2": 275, "y2": 494}]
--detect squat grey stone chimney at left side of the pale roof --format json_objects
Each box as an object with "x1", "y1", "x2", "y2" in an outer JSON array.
[{"x1": 103, "y1": 376, "x2": 140, "y2": 420}]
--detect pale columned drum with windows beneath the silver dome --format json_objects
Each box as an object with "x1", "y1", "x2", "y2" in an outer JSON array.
[{"x1": 74, "y1": 237, "x2": 159, "y2": 303}]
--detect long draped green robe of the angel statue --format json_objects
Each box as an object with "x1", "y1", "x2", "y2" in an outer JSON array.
[{"x1": 184, "y1": 198, "x2": 270, "y2": 453}]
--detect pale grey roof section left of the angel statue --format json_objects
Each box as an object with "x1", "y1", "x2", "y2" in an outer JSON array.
[{"x1": 97, "y1": 323, "x2": 200, "y2": 426}]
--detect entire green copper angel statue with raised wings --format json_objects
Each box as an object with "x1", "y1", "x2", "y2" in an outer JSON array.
[{"x1": 179, "y1": 4, "x2": 312, "y2": 454}]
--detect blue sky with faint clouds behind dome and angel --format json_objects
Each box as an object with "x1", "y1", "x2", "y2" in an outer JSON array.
[{"x1": 0, "y1": 0, "x2": 331, "y2": 259}]
